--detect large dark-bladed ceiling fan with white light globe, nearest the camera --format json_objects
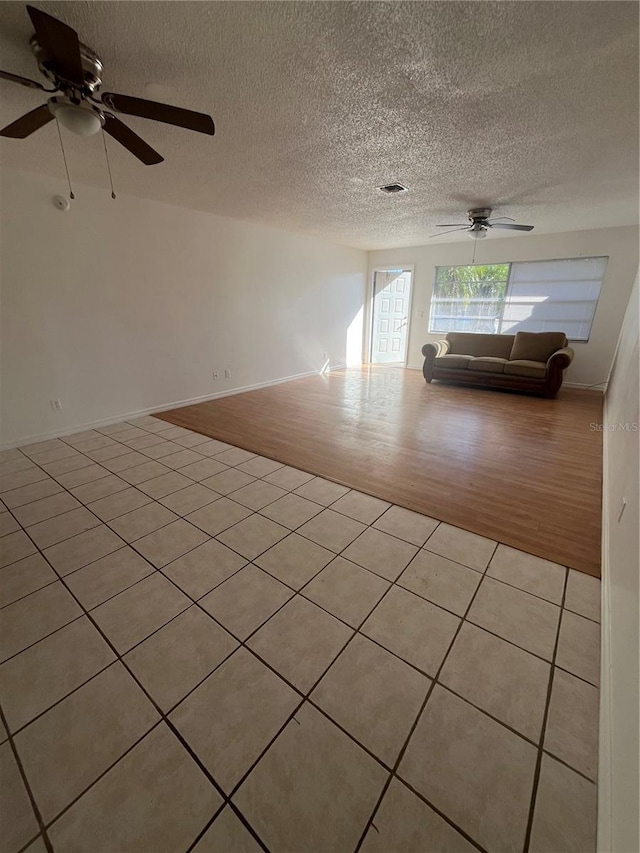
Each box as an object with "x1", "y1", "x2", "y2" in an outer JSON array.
[{"x1": 0, "y1": 6, "x2": 215, "y2": 166}]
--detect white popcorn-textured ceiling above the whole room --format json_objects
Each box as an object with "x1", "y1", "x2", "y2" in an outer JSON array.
[{"x1": 0, "y1": 0, "x2": 638, "y2": 249}]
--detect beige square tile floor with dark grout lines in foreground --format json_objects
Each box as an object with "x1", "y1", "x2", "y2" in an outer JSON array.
[{"x1": 0, "y1": 416, "x2": 600, "y2": 853}]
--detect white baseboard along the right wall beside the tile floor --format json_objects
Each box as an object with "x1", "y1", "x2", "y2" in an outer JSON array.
[{"x1": 596, "y1": 397, "x2": 613, "y2": 853}]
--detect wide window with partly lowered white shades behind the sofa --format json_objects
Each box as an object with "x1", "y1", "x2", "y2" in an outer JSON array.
[{"x1": 429, "y1": 258, "x2": 608, "y2": 341}]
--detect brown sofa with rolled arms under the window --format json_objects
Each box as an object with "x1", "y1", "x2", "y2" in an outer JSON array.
[{"x1": 422, "y1": 332, "x2": 573, "y2": 397}]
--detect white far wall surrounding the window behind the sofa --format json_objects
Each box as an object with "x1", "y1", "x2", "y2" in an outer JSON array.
[{"x1": 369, "y1": 227, "x2": 638, "y2": 386}]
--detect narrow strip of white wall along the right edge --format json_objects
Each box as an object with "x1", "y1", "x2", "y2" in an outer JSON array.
[{"x1": 598, "y1": 270, "x2": 640, "y2": 853}]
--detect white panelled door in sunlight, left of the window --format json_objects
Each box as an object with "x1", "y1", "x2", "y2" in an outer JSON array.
[{"x1": 371, "y1": 270, "x2": 411, "y2": 364}]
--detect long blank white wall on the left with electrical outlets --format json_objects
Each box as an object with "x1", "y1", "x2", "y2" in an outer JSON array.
[{"x1": 0, "y1": 167, "x2": 367, "y2": 445}]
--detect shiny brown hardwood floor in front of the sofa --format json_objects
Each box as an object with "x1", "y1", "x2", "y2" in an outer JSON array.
[{"x1": 158, "y1": 367, "x2": 602, "y2": 577}]
